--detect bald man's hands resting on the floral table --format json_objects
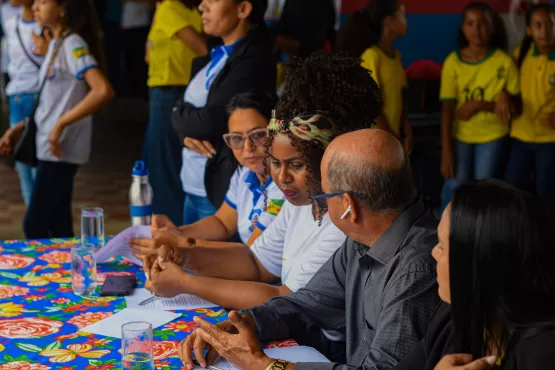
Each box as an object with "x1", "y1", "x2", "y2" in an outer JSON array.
[{"x1": 178, "y1": 311, "x2": 272, "y2": 369}]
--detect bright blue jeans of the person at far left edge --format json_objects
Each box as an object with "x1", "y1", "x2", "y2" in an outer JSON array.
[{"x1": 9, "y1": 94, "x2": 37, "y2": 206}]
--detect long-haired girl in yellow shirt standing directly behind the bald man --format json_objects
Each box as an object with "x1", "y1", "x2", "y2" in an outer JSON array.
[{"x1": 336, "y1": 0, "x2": 413, "y2": 153}]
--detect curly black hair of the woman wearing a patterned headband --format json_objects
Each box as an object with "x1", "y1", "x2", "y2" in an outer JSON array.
[{"x1": 264, "y1": 53, "x2": 382, "y2": 220}]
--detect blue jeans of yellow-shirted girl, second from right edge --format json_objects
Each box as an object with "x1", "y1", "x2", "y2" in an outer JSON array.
[{"x1": 441, "y1": 138, "x2": 507, "y2": 211}]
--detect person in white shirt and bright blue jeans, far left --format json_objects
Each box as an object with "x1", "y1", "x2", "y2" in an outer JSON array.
[{"x1": 3, "y1": 0, "x2": 43, "y2": 206}]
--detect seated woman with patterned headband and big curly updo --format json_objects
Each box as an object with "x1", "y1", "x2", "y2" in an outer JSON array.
[{"x1": 137, "y1": 55, "x2": 381, "y2": 309}]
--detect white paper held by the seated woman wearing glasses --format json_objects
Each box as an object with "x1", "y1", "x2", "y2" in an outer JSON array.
[{"x1": 96, "y1": 225, "x2": 152, "y2": 266}]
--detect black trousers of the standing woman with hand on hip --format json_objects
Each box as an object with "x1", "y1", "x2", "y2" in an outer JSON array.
[{"x1": 23, "y1": 161, "x2": 79, "y2": 239}]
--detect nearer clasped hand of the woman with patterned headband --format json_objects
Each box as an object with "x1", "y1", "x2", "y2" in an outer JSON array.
[{"x1": 149, "y1": 257, "x2": 189, "y2": 298}]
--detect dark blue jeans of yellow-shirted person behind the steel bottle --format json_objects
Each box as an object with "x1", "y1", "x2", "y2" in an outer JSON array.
[{"x1": 143, "y1": 87, "x2": 185, "y2": 225}]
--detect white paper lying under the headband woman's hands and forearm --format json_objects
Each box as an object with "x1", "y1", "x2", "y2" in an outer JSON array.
[{"x1": 125, "y1": 289, "x2": 218, "y2": 311}]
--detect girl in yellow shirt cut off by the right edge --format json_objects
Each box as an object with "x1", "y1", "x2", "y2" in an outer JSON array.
[{"x1": 505, "y1": 4, "x2": 555, "y2": 209}]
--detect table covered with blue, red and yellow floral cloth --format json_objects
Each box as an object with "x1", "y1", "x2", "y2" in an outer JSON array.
[{"x1": 0, "y1": 239, "x2": 295, "y2": 370}]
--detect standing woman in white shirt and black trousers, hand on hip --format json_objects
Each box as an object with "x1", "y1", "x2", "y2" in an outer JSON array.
[{"x1": 0, "y1": 0, "x2": 113, "y2": 239}]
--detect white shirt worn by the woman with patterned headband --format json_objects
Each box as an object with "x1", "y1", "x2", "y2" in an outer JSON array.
[{"x1": 251, "y1": 201, "x2": 346, "y2": 292}]
